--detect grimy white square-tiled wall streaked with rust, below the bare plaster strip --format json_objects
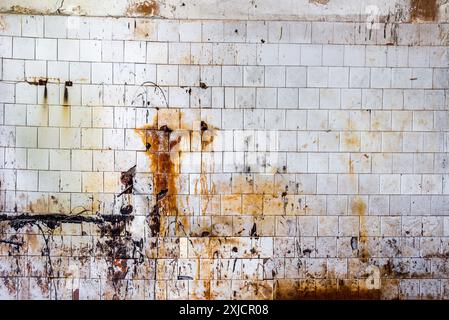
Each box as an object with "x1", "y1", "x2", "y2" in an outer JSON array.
[{"x1": 0, "y1": 14, "x2": 449, "y2": 299}]
